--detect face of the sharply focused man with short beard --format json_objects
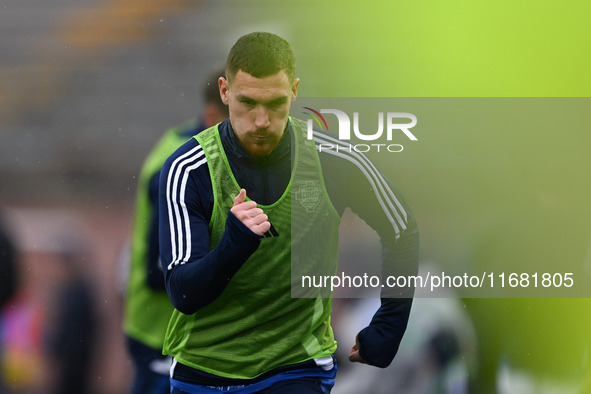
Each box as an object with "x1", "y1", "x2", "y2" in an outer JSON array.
[{"x1": 219, "y1": 70, "x2": 299, "y2": 157}]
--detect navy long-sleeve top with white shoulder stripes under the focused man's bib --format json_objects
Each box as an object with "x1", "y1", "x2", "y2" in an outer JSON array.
[{"x1": 159, "y1": 120, "x2": 419, "y2": 367}]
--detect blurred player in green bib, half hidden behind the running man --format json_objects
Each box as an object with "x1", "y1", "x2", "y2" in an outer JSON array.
[{"x1": 124, "y1": 70, "x2": 228, "y2": 394}]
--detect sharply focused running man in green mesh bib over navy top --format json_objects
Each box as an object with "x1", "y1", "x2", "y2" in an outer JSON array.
[{"x1": 160, "y1": 33, "x2": 418, "y2": 393}]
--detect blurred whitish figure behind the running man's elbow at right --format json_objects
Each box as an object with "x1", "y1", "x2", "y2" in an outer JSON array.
[{"x1": 333, "y1": 264, "x2": 476, "y2": 394}]
